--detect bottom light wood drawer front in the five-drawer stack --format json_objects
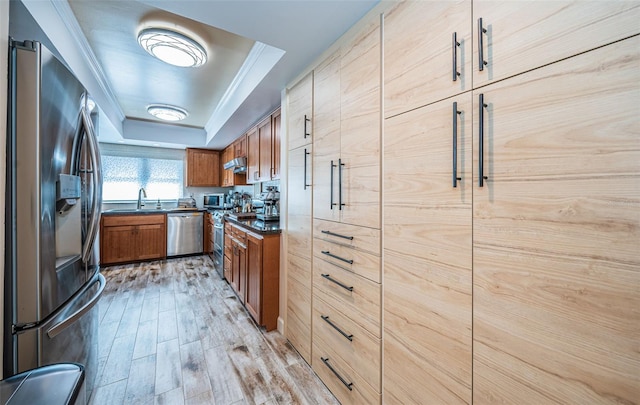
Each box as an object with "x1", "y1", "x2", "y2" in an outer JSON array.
[{"x1": 311, "y1": 339, "x2": 381, "y2": 405}]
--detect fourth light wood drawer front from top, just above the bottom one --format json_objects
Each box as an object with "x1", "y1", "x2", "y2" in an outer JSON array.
[{"x1": 313, "y1": 298, "x2": 382, "y2": 392}]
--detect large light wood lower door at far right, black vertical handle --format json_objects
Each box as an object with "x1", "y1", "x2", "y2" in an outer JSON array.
[{"x1": 473, "y1": 38, "x2": 640, "y2": 404}]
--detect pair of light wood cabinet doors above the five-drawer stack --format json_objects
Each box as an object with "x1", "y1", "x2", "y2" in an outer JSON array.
[{"x1": 313, "y1": 17, "x2": 381, "y2": 229}]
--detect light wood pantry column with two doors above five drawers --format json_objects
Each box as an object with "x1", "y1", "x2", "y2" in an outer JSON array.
[{"x1": 311, "y1": 17, "x2": 382, "y2": 404}]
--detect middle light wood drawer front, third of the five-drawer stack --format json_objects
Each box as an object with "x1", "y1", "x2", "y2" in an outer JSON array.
[{"x1": 313, "y1": 260, "x2": 381, "y2": 338}]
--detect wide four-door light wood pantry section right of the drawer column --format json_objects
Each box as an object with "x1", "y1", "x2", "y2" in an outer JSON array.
[{"x1": 383, "y1": 0, "x2": 640, "y2": 404}]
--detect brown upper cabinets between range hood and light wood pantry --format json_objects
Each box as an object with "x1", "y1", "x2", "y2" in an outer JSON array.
[{"x1": 247, "y1": 109, "x2": 280, "y2": 184}]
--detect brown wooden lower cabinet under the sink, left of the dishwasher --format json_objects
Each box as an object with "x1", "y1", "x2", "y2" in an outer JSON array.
[{"x1": 100, "y1": 214, "x2": 167, "y2": 265}]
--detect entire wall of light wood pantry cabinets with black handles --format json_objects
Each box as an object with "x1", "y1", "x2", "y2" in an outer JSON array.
[{"x1": 287, "y1": 0, "x2": 640, "y2": 405}]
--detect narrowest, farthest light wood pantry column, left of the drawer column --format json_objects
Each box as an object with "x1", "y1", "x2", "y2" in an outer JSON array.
[{"x1": 285, "y1": 72, "x2": 313, "y2": 363}]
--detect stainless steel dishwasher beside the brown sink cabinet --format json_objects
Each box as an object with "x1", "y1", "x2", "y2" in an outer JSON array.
[{"x1": 167, "y1": 212, "x2": 203, "y2": 256}]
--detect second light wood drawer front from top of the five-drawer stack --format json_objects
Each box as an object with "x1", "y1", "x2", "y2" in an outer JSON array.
[{"x1": 313, "y1": 239, "x2": 381, "y2": 283}]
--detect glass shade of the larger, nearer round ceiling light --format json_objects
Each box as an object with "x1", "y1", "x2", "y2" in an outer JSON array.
[{"x1": 138, "y1": 28, "x2": 207, "y2": 67}]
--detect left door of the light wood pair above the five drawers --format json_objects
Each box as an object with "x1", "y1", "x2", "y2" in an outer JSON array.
[{"x1": 313, "y1": 51, "x2": 340, "y2": 221}]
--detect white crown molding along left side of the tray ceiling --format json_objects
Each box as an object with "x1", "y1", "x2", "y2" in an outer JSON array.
[{"x1": 51, "y1": 1, "x2": 126, "y2": 122}]
